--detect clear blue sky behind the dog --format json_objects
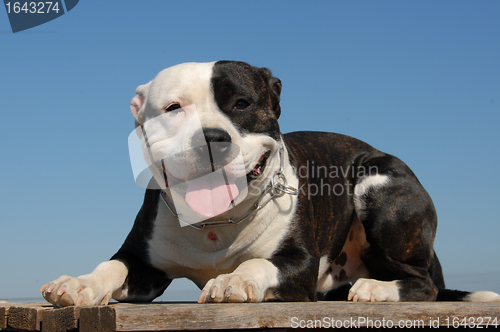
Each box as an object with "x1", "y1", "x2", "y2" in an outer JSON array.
[{"x1": 0, "y1": 0, "x2": 500, "y2": 299}]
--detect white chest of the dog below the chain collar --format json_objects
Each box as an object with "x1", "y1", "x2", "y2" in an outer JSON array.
[{"x1": 148, "y1": 179, "x2": 297, "y2": 287}]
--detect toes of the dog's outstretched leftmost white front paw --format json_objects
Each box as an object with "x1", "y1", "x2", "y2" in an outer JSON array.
[{"x1": 40, "y1": 276, "x2": 111, "y2": 307}]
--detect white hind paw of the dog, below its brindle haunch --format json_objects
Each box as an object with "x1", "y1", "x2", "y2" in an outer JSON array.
[{"x1": 347, "y1": 278, "x2": 399, "y2": 302}]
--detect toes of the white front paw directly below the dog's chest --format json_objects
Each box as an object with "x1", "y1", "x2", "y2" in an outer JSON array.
[{"x1": 198, "y1": 273, "x2": 264, "y2": 303}]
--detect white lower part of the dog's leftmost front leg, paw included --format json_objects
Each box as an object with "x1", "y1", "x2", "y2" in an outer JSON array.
[{"x1": 40, "y1": 260, "x2": 128, "y2": 307}]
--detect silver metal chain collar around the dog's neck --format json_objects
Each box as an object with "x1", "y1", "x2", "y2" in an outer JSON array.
[{"x1": 160, "y1": 146, "x2": 299, "y2": 230}]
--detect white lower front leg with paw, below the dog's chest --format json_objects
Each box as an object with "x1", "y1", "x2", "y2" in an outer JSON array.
[{"x1": 198, "y1": 258, "x2": 279, "y2": 303}]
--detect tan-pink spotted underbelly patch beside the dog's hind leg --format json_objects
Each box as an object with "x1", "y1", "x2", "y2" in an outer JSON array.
[{"x1": 316, "y1": 218, "x2": 368, "y2": 292}]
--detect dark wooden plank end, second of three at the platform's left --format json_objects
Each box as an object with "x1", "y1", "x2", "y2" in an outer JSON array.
[{"x1": 42, "y1": 307, "x2": 82, "y2": 332}]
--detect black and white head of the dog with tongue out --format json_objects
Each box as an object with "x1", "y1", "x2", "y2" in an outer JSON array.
[{"x1": 130, "y1": 61, "x2": 282, "y2": 221}]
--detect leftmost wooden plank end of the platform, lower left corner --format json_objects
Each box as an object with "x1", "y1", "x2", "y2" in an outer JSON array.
[{"x1": 7, "y1": 303, "x2": 54, "y2": 331}]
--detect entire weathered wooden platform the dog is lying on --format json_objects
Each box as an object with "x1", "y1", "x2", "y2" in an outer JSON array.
[{"x1": 0, "y1": 302, "x2": 500, "y2": 332}]
